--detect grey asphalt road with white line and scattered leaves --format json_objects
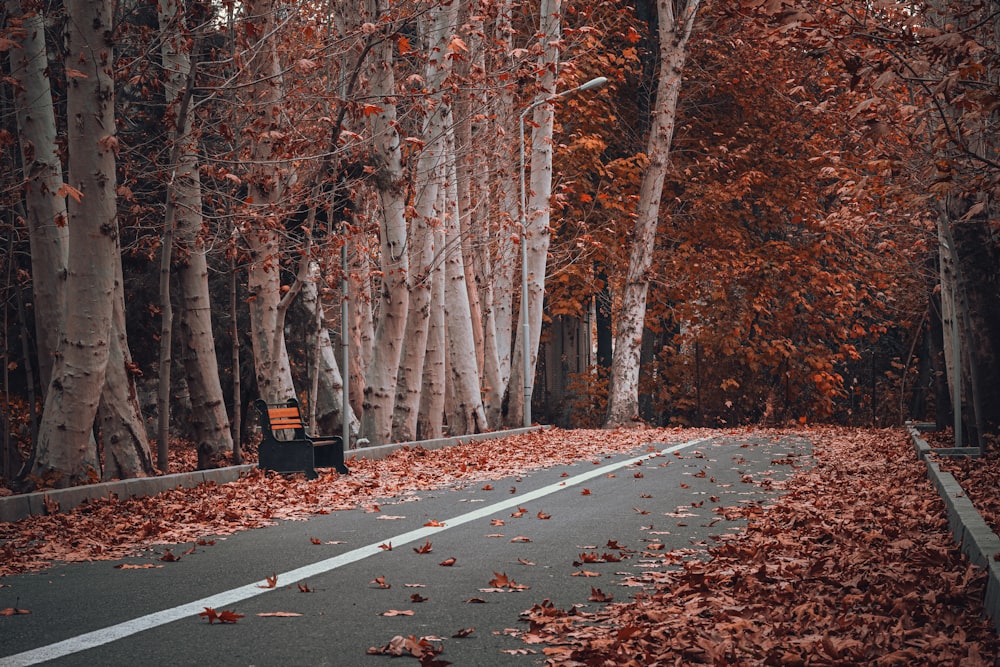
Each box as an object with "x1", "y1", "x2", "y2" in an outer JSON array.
[{"x1": 0, "y1": 436, "x2": 810, "y2": 667}]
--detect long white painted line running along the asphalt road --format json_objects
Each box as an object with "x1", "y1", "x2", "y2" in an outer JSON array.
[{"x1": 0, "y1": 438, "x2": 710, "y2": 667}]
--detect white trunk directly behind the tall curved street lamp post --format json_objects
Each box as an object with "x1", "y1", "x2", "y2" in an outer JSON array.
[{"x1": 507, "y1": 0, "x2": 562, "y2": 426}]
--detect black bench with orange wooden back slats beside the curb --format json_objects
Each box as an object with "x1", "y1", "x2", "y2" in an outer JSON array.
[{"x1": 254, "y1": 398, "x2": 350, "y2": 479}]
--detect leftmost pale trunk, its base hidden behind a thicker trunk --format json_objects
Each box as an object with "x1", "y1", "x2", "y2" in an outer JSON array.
[{"x1": 7, "y1": 0, "x2": 69, "y2": 398}]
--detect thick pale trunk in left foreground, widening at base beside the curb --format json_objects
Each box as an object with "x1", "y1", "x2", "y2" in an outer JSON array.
[{"x1": 31, "y1": 0, "x2": 120, "y2": 486}]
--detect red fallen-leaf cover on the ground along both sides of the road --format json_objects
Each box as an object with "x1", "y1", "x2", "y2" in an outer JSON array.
[{"x1": 0, "y1": 427, "x2": 1000, "y2": 667}]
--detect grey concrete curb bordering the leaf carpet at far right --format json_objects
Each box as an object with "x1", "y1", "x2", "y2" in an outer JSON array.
[{"x1": 906, "y1": 423, "x2": 1000, "y2": 632}]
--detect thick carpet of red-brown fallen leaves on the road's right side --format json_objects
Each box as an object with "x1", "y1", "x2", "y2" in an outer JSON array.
[{"x1": 525, "y1": 430, "x2": 1000, "y2": 667}]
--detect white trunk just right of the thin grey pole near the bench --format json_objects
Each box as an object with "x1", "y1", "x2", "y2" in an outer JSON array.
[{"x1": 361, "y1": 0, "x2": 410, "y2": 445}]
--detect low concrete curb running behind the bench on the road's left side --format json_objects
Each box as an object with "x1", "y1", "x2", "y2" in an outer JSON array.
[{"x1": 0, "y1": 426, "x2": 548, "y2": 523}]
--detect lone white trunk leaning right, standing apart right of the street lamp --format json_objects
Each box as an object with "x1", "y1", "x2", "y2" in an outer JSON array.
[{"x1": 605, "y1": 0, "x2": 700, "y2": 427}]
